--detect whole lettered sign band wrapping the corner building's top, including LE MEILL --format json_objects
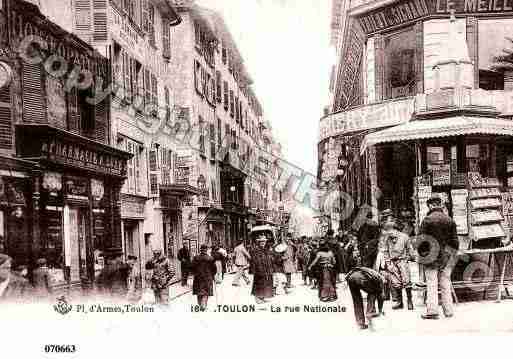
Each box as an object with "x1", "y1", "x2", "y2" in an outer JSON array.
[{"x1": 359, "y1": 0, "x2": 513, "y2": 33}]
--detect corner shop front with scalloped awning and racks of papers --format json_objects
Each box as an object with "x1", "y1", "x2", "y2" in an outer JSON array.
[{"x1": 362, "y1": 97, "x2": 513, "y2": 300}]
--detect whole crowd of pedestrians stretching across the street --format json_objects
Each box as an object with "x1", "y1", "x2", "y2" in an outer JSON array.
[{"x1": 0, "y1": 197, "x2": 458, "y2": 329}]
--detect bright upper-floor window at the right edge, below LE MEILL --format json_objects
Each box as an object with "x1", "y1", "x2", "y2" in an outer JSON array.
[{"x1": 478, "y1": 19, "x2": 513, "y2": 90}]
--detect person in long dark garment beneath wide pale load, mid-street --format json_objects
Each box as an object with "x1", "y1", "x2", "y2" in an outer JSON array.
[{"x1": 250, "y1": 234, "x2": 274, "y2": 304}]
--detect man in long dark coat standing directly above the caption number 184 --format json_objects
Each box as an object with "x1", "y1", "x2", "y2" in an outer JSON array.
[{"x1": 191, "y1": 244, "x2": 217, "y2": 312}]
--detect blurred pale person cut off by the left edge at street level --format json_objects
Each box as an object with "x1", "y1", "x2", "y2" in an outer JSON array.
[{"x1": 0, "y1": 254, "x2": 32, "y2": 303}]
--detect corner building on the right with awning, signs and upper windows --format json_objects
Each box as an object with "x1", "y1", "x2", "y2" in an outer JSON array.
[{"x1": 318, "y1": 0, "x2": 513, "y2": 294}]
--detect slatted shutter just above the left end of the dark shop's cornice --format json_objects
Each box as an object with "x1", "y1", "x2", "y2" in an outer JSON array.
[{"x1": 22, "y1": 63, "x2": 46, "y2": 123}]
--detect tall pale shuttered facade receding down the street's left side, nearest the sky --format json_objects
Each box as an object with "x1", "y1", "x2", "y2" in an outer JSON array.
[{"x1": 171, "y1": 1, "x2": 288, "y2": 252}]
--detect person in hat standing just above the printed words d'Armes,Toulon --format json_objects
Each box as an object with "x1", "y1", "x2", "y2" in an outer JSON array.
[{"x1": 146, "y1": 249, "x2": 176, "y2": 305}]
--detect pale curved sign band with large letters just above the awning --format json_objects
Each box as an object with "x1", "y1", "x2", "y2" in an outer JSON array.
[{"x1": 319, "y1": 97, "x2": 415, "y2": 141}]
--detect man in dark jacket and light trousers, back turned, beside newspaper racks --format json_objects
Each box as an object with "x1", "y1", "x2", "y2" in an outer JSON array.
[{"x1": 417, "y1": 196, "x2": 459, "y2": 319}]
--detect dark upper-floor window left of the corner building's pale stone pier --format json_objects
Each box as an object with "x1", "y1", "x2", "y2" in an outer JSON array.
[{"x1": 384, "y1": 28, "x2": 416, "y2": 99}]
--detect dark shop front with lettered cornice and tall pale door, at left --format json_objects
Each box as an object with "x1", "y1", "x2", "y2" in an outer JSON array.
[{"x1": 16, "y1": 125, "x2": 130, "y2": 291}]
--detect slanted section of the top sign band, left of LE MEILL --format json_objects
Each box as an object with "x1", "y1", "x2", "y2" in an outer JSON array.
[{"x1": 359, "y1": 0, "x2": 430, "y2": 33}]
